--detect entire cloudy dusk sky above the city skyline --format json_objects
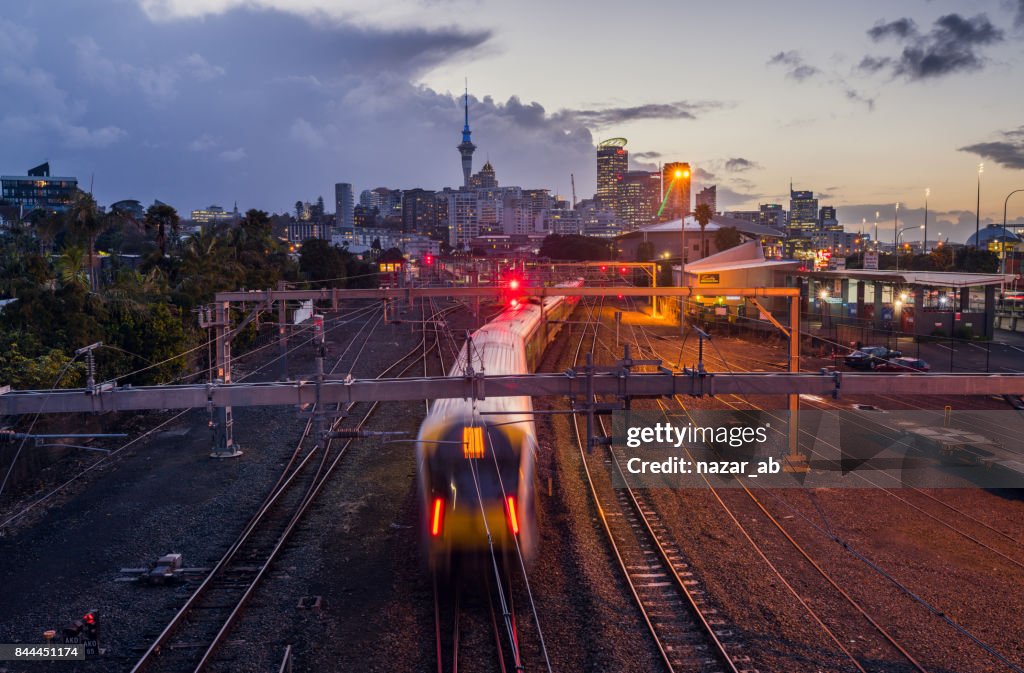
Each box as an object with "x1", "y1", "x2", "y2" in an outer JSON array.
[{"x1": 0, "y1": 0, "x2": 1024, "y2": 240}]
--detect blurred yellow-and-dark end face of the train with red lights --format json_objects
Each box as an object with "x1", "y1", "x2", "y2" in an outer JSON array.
[{"x1": 419, "y1": 409, "x2": 537, "y2": 572}]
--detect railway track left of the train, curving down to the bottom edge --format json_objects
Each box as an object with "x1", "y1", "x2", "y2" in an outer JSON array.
[{"x1": 131, "y1": 305, "x2": 452, "y2": 673}]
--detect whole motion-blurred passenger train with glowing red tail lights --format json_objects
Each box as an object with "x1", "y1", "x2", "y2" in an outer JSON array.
[{"x1": 417, "y1": 278, "x2": 583, "y2": 573}]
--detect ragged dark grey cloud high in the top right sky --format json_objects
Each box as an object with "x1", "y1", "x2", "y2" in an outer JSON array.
[{"x1": 859, "y1": 13, "x2": 1004, "y2": 81}]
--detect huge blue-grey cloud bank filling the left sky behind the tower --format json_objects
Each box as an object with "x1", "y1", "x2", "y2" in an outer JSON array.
[{"x1": 0, "y1": 0, "x2": 614, "y2": 211}]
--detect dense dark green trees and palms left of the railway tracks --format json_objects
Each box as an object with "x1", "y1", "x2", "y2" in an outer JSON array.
[{"x1": 0, "y1": 201, "x2": 377, "y2": 389}]
